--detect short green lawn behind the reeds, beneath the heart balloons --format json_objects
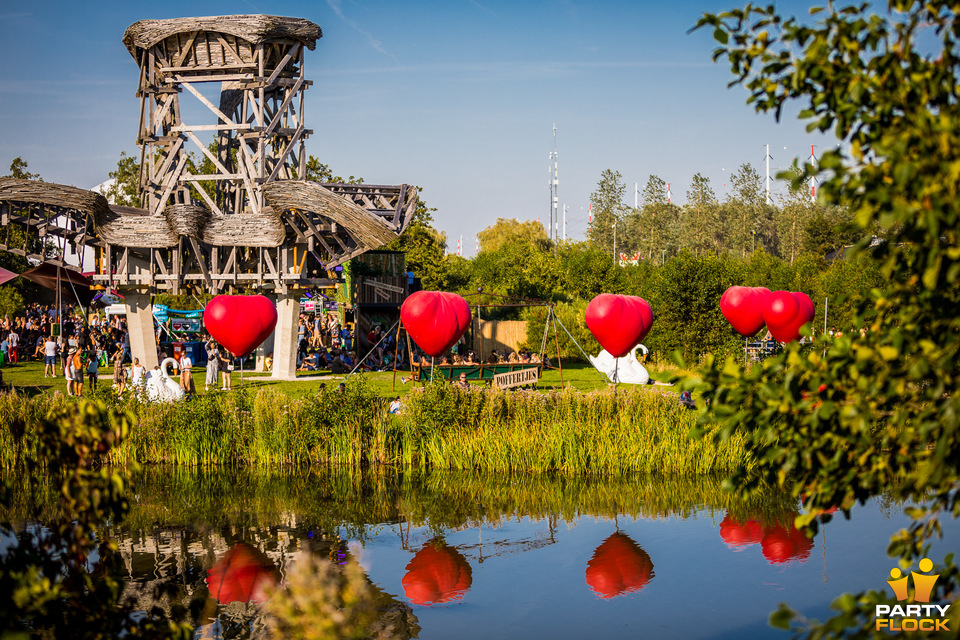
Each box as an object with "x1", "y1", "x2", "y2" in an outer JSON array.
[{"x1": 0, "y1": 362, "x2": 675, "y2": 396}]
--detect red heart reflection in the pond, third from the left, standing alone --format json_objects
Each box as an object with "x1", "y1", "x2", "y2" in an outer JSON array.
[{"x1": 586, "y1": 531, "x2": 653, "y2": 598}]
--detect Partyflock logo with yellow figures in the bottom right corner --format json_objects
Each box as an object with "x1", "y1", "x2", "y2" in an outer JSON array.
[{"x1": 877, "y1": 558, "x2": 950, "y2": 631}]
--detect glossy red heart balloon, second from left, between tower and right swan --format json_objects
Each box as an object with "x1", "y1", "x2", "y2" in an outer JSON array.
[{"x1": 400, "y1": 291, "x2": 471, "y2": 358}]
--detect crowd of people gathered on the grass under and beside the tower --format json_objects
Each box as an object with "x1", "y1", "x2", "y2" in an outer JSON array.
[{"x1": 0, "y1": 303, "x2": 549, "y2": 396}]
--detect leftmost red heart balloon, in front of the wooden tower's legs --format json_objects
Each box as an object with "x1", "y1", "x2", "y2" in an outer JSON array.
[{"x1": 203, "y1": 296, "x2": 277, "y2": 358}]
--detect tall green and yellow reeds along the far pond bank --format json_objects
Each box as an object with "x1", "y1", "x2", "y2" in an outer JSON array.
[{"x1": 0, "y1": 377, "x2": 753, "y2": 476}]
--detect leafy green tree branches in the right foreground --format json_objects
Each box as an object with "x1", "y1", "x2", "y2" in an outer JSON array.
[{"x1": 698, "y1": 0, "x2": 960, "y2": 638}]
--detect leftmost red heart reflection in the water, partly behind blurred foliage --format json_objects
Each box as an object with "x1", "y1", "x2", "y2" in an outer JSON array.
[{"x1": 207, "y1": 542, "x2": 280, "y2": 604}]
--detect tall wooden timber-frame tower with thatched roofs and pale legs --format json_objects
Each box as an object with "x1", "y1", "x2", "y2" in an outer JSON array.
[{"x1": 0, "y1": 15, "x2": 417, "y2": 378}]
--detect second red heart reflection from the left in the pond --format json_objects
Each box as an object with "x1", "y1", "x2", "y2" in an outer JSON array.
[{"x1": 402, "y1": 539, "x2": 473, "y2": 607}]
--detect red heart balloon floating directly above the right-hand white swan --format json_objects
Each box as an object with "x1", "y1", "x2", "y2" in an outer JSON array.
[{"x1": 584, "y1": 293, "x2": 653, "y2": 358}]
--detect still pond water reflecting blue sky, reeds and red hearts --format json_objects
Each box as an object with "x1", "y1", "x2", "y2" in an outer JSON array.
[{"x1": 111, "y1": 470, "x2": 936, "y2": 639}]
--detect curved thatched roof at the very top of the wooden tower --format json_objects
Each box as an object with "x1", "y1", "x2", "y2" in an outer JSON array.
[{"x1": 123, "y1": 15, "x2": 323, "y2": 58}]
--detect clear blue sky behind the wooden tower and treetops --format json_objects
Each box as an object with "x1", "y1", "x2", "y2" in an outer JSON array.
[{"x1": 0, "y1": 0, "x2": 836, "y2": 257}]
